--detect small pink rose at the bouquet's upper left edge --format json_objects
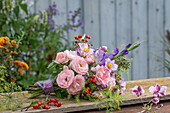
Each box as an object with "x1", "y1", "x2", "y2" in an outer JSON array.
[{"x1": 55, "y1": 52, "x2": 68, "y2": 64}]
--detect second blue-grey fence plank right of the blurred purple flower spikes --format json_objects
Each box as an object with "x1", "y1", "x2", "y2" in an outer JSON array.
[{"x1": 100, "y1": 0, "x2": 116, "y2": 51}]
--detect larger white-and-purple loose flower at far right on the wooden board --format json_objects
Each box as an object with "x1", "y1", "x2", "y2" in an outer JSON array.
[{"x1": 149, "y1": 84, "x2": 167, "y2": 97}]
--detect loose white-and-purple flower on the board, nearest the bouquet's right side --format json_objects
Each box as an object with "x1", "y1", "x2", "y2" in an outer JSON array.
[{"x1": 132, "y1": 86, "x2": 145, "y2": 97}]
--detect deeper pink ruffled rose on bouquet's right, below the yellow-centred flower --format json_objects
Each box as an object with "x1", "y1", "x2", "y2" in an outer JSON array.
[{"x1": 96, "y1": 66, "x2": 110, "y2": 85}]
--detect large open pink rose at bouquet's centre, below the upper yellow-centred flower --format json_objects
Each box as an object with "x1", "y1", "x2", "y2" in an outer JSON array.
[{"x1": 69, "y1": 56, "x2": 89, "y2": 75}]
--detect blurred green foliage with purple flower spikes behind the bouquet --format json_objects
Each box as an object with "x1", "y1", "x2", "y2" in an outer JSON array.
[{"x1": 0, "y1": 0, "x2": 83, "y2": 89}]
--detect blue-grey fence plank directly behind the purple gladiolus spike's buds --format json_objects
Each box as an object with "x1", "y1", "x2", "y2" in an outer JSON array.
[{"x1": 116, "y1": 0, "x2": 133, "y2": 80}]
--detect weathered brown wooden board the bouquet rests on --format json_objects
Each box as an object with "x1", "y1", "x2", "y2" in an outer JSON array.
[{"x1": 1, "y1": 77, "x2": 170, "y2": 113}]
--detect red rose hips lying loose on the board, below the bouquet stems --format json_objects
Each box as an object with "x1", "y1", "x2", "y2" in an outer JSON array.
[{"x1": 32, "y1": 99, "x2": 62, "y2": 109}]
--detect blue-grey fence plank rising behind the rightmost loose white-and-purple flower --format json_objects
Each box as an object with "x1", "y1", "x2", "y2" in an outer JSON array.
[{"x1": 148, "y1": 0, "x2": 164, "y2": 78}]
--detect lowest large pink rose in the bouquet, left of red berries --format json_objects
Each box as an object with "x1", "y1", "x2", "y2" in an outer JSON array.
[{"x1": 67, "y1": 75, "x2": 85, "y2": 95}]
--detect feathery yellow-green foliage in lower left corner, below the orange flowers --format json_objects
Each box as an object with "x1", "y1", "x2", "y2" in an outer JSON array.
[{"x1": 0, "y1": 82, "x2": 23, "y2": 111}]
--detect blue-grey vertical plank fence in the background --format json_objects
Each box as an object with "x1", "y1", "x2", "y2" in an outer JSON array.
[{"x1": 30, "y1": 0, "x2": 170, "y2": 80}]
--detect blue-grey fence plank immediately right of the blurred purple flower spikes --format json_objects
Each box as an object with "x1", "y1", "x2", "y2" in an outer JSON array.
[{"x1": 83, "y1": 0, "x2": 101, "y2": 48}]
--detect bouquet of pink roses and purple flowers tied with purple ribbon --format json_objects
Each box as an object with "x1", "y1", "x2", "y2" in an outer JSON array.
[{"x1": 27, "y1": 34, "x2": 142, "y2": 109}]
